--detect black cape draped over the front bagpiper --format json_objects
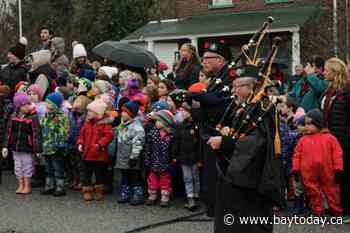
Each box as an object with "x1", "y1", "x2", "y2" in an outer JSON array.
[{"x1": 221, "y1": 106, "x2": 284, "y2": 206}]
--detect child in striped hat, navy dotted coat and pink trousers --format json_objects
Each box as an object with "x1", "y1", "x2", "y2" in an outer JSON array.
[{"x1": 144, "y1": 110, "x2": 176, "y2": 207}]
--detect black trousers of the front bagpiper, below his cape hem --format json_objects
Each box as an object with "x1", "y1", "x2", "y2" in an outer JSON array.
[{"x1": 214, "y1": 178, "x2": 273, "y2": 233}]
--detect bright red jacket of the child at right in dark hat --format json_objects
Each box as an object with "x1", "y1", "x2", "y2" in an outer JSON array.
[{"x1": 293, "y1": 130, "x2": 343, "y2": 177}]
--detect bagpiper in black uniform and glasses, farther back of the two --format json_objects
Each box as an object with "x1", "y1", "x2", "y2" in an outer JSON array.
[{"x1": 191, "y1": 43, "x2": 232, "y2": 217}]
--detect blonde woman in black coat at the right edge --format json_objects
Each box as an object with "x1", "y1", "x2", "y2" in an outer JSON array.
[{"x1": 321, "y1": 58, "x2": 350, "y2": 223}]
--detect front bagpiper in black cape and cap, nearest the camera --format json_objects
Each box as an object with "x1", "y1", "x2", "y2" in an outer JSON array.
[{"x1": 208, "y1": 65, "x2": 283, "y2": 233}]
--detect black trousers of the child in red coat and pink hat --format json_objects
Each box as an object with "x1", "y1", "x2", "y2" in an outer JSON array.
[{"x1": 83, "y1": 160, "x2": 107, "y2": 186}]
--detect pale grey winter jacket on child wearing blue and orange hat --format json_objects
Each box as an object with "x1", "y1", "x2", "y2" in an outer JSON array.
[{"x1": 116, "y1": 117, "x2": 145, "y2": 169}]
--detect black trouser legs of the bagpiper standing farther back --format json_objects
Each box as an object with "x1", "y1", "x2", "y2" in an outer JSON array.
[{"x1": 203, "y1": 144, "x2": 218, "y2": 217}]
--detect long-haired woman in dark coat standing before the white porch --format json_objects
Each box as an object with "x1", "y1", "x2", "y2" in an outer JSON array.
[{"x1": 171, "y1": 43, "x2": 201, "y2": 90}]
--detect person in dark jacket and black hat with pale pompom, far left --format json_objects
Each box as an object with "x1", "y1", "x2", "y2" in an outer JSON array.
[{"x1": 0, "y1": 37, "x2": 28, "y2": 94}]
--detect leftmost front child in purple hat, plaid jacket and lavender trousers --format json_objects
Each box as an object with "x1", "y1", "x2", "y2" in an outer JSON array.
[{"x1": 2, "y1": 92, "x2": 41, "y2": 194}]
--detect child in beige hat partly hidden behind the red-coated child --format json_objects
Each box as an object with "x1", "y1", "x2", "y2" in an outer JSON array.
[{"x1": 67, "y1": 95, "x2": 92, "y2": 190}]
